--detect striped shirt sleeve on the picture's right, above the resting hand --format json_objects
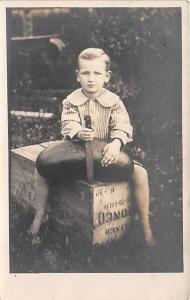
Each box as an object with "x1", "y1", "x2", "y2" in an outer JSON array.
[{"x1": 110, "y1": 100, "x2": 133, "y2": 145}]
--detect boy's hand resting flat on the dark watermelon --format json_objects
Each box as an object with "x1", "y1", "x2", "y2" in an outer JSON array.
[{"x1": 101, "y1": 139, "x2": 121, "y2": 167}]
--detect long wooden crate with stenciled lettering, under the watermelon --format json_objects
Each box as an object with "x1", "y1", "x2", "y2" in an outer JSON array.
[{"x1": 10, "y1": 142, "x2": 131, "y2": 245}]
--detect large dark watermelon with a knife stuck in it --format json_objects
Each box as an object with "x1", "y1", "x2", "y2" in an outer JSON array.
[{"x1": 36, "y1": 139, "x2": 134, "y2": 182}]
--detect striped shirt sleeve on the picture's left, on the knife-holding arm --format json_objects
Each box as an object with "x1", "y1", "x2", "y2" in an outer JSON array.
[{"x1": 61, "y1": 99, "x2": 82, "y2": 139}]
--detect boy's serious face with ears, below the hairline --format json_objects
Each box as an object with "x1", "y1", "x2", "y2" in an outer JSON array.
[{"x1": 77, "y1": 58, "x2": 110, "y2": 97}]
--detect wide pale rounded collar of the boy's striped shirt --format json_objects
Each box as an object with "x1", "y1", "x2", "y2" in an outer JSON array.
[{"x1": 67, "y1": 88, "x2": 119, "y2": 107}]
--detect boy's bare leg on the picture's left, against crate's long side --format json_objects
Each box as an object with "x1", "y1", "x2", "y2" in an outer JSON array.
[{"x1": 29, "y1": 169, "x2": 48, "y2": 236}]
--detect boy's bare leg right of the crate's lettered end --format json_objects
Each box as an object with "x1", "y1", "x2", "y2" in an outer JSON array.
[{"x1": 132, "y1": 164, "x2": 155, "y2": 246}]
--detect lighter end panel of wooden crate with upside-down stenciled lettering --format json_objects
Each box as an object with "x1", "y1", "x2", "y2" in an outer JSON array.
[{"x1": 93, "y1": 182, "x2": 131, "y2": 244}]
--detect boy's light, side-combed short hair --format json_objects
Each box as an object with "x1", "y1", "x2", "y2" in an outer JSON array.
[{"x1": 78, "y1": 48, "x2": 111, "y2": 71}]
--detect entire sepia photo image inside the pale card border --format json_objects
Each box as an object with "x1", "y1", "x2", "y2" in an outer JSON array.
[{"x1": 6, "y1": 5, "x2": 184, "y2": 273}]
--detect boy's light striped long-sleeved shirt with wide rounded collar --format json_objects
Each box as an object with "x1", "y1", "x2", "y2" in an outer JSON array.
[{"x1": 61, "y1": 89, "x2": 133, "y2": 145}]
